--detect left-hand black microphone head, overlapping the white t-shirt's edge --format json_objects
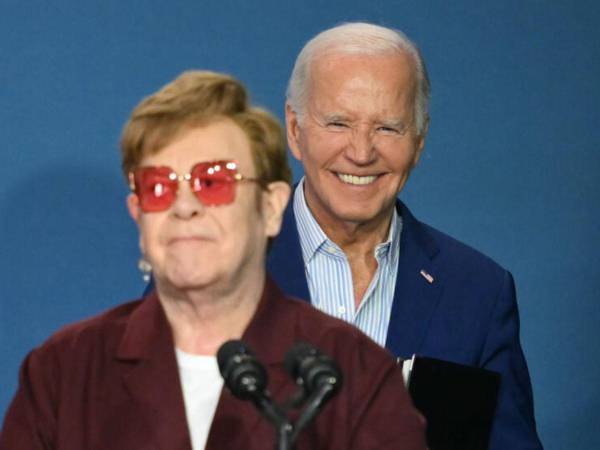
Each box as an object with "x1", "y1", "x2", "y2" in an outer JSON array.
[{"x1": 217, "y1": 340, "x2": 268, "y2": 400}]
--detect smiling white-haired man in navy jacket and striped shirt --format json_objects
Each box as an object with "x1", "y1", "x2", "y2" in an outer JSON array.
[{"x1": 269, "y1": 23, "x2": 541, "y2": 450}]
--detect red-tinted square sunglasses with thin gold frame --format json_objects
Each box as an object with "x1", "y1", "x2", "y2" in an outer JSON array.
[{"x1": 129, "y1": 161, "x2": 260, "y2": 212}]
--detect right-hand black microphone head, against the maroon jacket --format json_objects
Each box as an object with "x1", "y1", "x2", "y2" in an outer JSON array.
[{"x1": 284, "y1": 342, "x2": 342, "y2": 396}]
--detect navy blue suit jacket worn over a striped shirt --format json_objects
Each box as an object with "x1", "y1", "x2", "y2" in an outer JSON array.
[{"x1": 268, "y1": 201, "x2": 542, "y2": 450}]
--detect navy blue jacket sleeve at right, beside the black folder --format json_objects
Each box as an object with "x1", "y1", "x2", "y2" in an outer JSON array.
[{"x1": 480, "y1": 271, "x2": 542, "y2": 450}]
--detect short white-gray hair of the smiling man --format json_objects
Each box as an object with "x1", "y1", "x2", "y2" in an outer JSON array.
[{"x1": 286, "y1": 22, "x2": 431, "y2": 134}]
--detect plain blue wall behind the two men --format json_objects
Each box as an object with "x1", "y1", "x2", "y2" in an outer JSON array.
[{"x1": 0, "y1": 0, "x2": 600, "y2": 449}]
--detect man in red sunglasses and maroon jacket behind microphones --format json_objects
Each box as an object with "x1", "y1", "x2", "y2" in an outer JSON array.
[{"x1": 0, "y1": 72, "x2": 425, "y2": 450}]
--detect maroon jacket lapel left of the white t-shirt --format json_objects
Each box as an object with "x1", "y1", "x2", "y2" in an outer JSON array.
[{"x1": 117, "y1": 292, "x2": 191, "y2": 450}]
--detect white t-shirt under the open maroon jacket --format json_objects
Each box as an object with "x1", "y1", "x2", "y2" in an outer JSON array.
[{"x1": 175, "y1": 348, "x2": 223, "y2": 450}]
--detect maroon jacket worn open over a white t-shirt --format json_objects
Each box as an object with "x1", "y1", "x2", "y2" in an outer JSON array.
[{"x1": 0, "y1": 281, "x2": 425, "y2": 450}]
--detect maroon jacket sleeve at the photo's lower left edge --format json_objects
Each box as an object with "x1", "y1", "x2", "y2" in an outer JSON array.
[{"x1": 0, "y1": 350, "x2": 58, "y2": 450}]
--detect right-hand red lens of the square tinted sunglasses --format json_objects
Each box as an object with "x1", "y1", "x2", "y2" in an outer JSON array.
[{"x1": 191, "y1": 161, "x2": 237, "y2": 206}]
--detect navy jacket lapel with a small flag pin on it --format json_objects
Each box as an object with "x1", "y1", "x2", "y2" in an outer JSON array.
[{"x1": 386, "y1": 201, "x2": 443, "y2": 358}]
